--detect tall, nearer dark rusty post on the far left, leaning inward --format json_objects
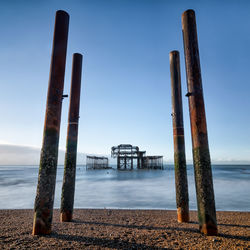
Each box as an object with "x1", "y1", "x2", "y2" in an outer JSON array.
[{"x1": 32, "y1": 10, "x2": 69, "y2": 235}]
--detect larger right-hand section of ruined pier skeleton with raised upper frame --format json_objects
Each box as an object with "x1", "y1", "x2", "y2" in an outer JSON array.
[{"x1": 111, "y1": 144, "x2": 163, "y2": 170}]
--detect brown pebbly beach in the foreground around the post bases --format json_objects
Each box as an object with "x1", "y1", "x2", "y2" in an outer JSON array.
[{"x1": 0, "y1": 209, "x2": 250, "y2": 249}]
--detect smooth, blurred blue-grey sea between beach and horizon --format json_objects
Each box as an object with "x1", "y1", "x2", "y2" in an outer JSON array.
[{"x1": 0, "y1": 165, "x2": 250, "y2": 211}]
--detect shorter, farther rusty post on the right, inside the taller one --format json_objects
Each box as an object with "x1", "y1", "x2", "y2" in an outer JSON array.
[{"x1": 169, "y1": 51, "x2": 189, "y2": 222}]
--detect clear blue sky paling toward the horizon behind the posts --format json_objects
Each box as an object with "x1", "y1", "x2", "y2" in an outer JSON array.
[{"x1": 0, "y1": 0, "x2": 250, "y2": 164}]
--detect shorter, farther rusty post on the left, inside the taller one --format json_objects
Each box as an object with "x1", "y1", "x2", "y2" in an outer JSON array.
[{"x1": 60, "y1": 53, "x2": 82, "y2": 222}]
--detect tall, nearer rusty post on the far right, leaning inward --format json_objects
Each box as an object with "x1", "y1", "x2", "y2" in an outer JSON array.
[{"x1": 182, "y1": 10, "x2": 218, "y2": 235}]
